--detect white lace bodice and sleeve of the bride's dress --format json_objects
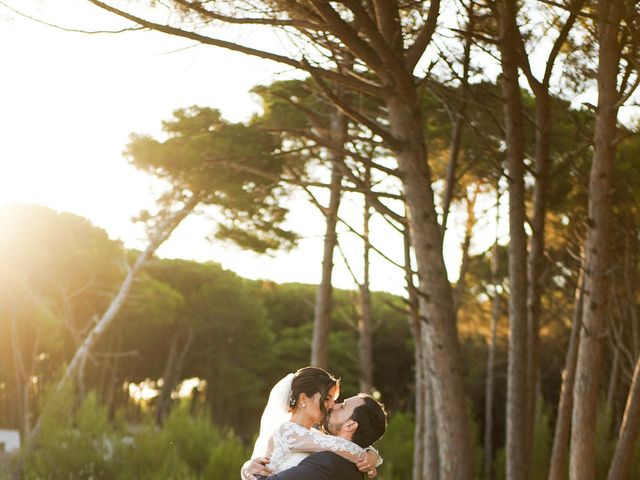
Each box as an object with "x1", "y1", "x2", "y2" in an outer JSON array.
[{"x1": 268, "y1": 422, "x2": 365, "y2": 473}]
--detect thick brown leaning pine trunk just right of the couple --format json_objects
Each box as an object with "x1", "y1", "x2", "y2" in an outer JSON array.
[{"x1": 387, "y1": 89, "x2": 473, "y2": 480}]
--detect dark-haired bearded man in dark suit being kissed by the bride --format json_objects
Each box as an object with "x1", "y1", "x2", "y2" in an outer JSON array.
[{"x1": 241, "y1": 393, "x2": 387, "y2": 480}]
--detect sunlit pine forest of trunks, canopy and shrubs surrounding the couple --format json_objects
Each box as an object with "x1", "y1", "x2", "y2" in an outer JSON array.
[{"x1": 0, "y1": 0, "x2": 640, "y2": 480}]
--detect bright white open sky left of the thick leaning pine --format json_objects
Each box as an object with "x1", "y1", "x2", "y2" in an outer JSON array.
[{"x1": 0, "y1": 0, "x2": 424, "y2": 293}]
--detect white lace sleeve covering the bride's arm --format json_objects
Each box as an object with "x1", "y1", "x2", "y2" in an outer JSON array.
[{"x1": 280, "y1": 422, "x2": 378, "y2": 463}]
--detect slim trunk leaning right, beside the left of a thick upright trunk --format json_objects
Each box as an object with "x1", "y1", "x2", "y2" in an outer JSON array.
[{"x1": 549, "y1": 266, "x2": 584, "y2": 480}]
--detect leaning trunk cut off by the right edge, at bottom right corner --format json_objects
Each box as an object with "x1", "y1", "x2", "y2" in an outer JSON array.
[{"x1": 607, "y1": 350, "x2": 640, "y2": 480}]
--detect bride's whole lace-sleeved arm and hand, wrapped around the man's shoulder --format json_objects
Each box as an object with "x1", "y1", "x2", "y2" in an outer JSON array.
[{"x1": 286, "y1": 427, "x2": 382, "y2": 468}]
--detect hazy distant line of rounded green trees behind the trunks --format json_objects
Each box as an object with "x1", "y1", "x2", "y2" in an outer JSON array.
[{"x1": 0, "y1": 205, "x2": 570, "y2": 445}]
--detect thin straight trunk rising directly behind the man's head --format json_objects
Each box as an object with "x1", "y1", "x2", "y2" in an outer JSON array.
[{"x1": 358, "y1": 168, "x2": 373, "y2": 392}]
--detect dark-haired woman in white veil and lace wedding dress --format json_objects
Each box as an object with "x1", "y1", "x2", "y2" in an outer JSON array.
[{"x1": 241, "y1": 367, "x2": 382, "y2": 480}]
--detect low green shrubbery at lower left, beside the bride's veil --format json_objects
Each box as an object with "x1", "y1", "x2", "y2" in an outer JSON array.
[{"x1": 18, "y1": 387, "x2": 250, "y2": 480}]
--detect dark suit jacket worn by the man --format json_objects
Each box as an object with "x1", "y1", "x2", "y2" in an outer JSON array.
[{"x1": 259, "y1": 452, "x2": 364, "y2": 480}]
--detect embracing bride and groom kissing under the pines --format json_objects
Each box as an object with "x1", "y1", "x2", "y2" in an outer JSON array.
[{"x1": 240, "y1": 367, "x2": 387, "y2": 480}]
